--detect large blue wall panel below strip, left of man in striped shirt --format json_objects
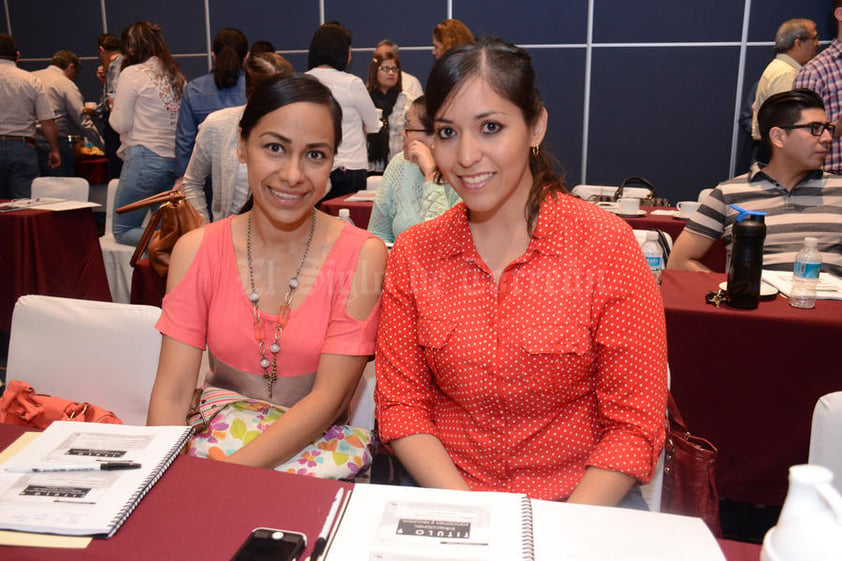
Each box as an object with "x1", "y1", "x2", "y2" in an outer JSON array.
[{"x1": 588, "y1": 47, "x2": 739, "y2": 202}]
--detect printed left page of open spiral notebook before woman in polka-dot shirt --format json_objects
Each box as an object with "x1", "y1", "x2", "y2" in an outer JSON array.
[{"x1": 326, "y1": 485, "x2": 535, "y2": 561}]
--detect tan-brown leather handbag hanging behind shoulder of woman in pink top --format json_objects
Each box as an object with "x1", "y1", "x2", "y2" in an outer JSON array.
[{"x1": 115, "y1": 189, "x2": 202, "y2": 277}]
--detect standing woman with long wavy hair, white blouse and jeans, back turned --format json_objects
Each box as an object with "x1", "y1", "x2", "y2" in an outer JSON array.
[{"x1": 108, "y1": 21, "x2": 185, "y2": 245}]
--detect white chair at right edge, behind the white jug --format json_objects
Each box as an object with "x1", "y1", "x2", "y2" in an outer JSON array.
[{"x1": 809, "y1": 391, "x2": 842, "y2": 493}]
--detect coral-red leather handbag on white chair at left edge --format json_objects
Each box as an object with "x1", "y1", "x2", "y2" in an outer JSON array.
[{"x1": 0, "y1": 380, "x2": 123, "y2": 429}]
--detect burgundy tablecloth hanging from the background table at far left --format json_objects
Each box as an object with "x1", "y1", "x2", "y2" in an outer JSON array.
[{"x1": 0, "y1": 208, "x2": 111, "y2": 332}]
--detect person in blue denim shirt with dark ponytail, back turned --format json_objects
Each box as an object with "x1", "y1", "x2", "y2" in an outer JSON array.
[{"x1": 175, "y1": 27, "x2": 249, "y2": 182}]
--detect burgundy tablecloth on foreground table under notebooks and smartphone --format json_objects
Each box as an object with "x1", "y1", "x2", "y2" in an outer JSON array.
[{"x1": 0, "y1": 423, "x2": 760, "y2": 561}]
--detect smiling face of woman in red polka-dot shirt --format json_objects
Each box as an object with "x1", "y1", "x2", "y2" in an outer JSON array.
[{"x1": 433, "y1": 76, "x2": 546, "y2": 221}]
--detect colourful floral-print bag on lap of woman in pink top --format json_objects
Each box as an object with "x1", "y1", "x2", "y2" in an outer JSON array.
[{"x1": 187, "y1": 386, "x2": 373, "y2": 480}]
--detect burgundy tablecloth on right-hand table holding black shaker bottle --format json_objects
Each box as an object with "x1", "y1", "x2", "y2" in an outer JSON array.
[{"x1": 661, "y1": 271, "x2": 842, "y2": 505}]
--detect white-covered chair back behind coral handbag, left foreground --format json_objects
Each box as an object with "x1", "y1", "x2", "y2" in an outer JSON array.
[{"x1": 6, "y1": 295, "x2": 161, "y2": 425}]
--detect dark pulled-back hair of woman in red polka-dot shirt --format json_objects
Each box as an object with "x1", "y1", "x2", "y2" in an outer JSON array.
[{"x1": 424, "y1": 37, "x2": 567, "y2": 231}]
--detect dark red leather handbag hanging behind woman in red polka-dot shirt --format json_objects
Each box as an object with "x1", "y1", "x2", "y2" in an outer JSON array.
[{"x1": 661, "y1": 392, "x2": 722, "y2": 537}]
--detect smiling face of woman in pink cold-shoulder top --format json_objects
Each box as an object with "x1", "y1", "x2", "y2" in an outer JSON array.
[{"x1": 237, "y1": 102, "x2": 336, "y2": 226}]
